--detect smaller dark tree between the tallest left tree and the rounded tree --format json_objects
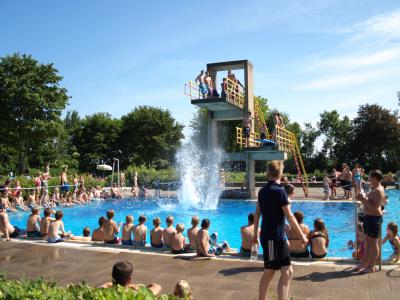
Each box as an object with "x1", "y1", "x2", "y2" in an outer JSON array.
[{"x1": 73, "y1": 113, "x2": 121, "y2": 172}]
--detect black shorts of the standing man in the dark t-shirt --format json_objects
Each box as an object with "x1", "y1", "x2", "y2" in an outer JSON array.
[{"x1": 261, "y1": 240, "x2": 291, "y2": 270}]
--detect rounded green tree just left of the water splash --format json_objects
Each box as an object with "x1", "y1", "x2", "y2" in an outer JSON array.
[{"x1": 120, "y1": 106, "x2": 184, "y2": 168}]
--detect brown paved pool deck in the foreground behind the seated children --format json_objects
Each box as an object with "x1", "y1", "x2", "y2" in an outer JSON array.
[{"x1": 0, "y1": 241, "x2": 400, "y2": 300}]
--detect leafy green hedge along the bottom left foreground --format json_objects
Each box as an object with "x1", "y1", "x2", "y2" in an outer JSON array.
[{"x1": 0, "y1": 275, "x2": 184, "y2": 300}]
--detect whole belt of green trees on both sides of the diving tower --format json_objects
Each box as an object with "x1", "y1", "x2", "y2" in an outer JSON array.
[{"x1": 0, "y1": 53, "x2": 400, "y2": 174}]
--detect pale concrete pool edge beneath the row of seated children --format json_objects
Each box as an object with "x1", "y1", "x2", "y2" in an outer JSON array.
[{"x1": 0, "y1": 238, "x2": 400, "y2": 270}]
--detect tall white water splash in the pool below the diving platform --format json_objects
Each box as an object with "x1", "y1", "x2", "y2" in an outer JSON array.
[{"x1": 176, "y1": 141, "x2": 223, "y2": 210}]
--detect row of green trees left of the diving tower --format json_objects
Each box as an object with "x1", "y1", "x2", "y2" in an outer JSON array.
[{"x1": 0, "y1": 54, "x2": 184, "y2": 174}]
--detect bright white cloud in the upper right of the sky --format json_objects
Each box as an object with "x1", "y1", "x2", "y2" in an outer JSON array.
[{"x1": 294, "y1": 10, "x2": 400, "y2": 90}]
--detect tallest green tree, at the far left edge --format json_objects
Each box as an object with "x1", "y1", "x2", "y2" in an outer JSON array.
[{"x1": 0, "y1": 54, "x2": 68, "y2": 173}]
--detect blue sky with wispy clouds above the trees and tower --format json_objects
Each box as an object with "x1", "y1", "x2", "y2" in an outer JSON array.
[{"x1": 0, "y1": 0, "x2": 400, "y2": 137}]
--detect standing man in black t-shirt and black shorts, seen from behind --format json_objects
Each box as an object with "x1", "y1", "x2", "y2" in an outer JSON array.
[{"x1": 253, "y1": 160, "x2": 307, "y2": 300}]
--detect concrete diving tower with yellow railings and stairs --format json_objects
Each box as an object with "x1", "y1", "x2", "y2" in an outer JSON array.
[{"x1": 184, "y1": 60, "x2": 308, "y2": 199}]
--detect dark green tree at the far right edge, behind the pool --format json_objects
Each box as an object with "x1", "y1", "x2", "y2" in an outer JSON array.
[{"x1": 348, "y1": 104, "x2": 400, "y2": 171}]
